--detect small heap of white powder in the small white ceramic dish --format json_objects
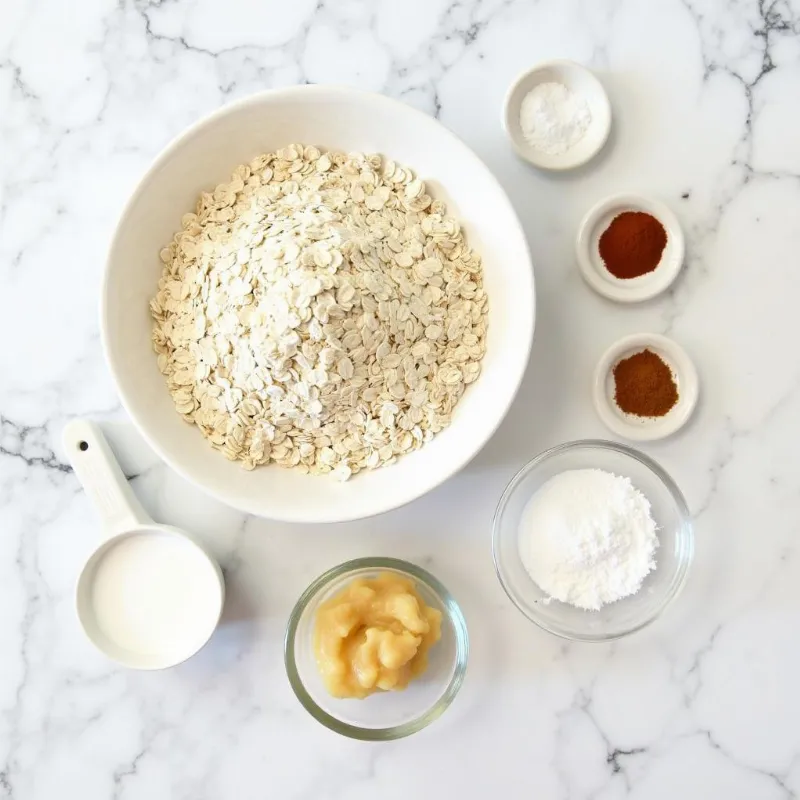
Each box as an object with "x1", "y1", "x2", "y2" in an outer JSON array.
[{"x1": 519, "y1": 83, "x2": 592, "y2": 156}]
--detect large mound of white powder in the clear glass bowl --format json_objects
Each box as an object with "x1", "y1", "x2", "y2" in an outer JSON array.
[{"x1": 519, "y1": 469, "x2": 658, "y2": 611}]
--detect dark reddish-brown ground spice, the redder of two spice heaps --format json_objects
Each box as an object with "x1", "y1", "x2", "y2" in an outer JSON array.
[{"x1": 599, "y1": 211, "x2": 667, "y2": 279}]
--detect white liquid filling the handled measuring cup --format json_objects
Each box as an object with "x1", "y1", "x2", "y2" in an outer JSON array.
[{"x1": 89, "y1": 531, "x2": 220, "y2": 656}]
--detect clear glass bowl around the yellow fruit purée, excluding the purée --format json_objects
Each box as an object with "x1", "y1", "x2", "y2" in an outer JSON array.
[{"x1": 284, "y1": 557, "x2": 469, "y2": 741}]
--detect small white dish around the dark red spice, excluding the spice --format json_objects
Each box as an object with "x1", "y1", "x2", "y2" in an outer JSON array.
[{"x1": 575, "y1": 194, "x2": 685, "y2": 303}]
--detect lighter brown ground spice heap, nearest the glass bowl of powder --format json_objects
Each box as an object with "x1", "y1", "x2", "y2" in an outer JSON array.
[{"x1": 614, "y1": 350, "x2": 678, "y2": 417}]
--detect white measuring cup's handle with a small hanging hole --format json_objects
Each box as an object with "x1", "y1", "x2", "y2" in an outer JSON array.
[{"x1": 63, "y1": 419, "x2": 153, "y2": 537}]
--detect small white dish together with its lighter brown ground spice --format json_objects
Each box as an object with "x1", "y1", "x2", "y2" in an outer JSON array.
[{"x1": 592, "y1": 333, "x2": 699, "y2": 442}]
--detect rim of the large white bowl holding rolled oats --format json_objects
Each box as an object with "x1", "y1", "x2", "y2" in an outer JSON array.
[{"x1": 99, "y1": 84, "x2": 536, "y2": 524}]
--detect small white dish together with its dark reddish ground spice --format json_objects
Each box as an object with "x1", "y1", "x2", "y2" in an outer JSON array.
[{"x1": 576, "y1": 194, "x2": 685, "y2": 303}]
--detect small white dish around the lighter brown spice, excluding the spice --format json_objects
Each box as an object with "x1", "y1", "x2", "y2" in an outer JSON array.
[{"x1": 592, "y1": 333, "x2": 699, "y2": 442}]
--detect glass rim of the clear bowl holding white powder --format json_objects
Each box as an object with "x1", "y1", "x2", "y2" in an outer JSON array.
[{"x1": 492, "y1": 439, "x2": 694, "y2": 642}]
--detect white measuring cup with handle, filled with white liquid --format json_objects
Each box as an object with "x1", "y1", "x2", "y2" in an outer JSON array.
[{"x1": 63, "y1": 420, "x2": 225, "y2": 669}]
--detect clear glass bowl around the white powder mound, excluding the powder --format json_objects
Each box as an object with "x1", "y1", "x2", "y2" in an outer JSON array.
[{"x1": 492, "y1": 440, "x2": 694, "y2": 642}]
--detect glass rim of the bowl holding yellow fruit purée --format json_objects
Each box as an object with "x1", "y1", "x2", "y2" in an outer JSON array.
[{"x1": 283, "y1": 556, "x2": 469, "y2": 742}]
